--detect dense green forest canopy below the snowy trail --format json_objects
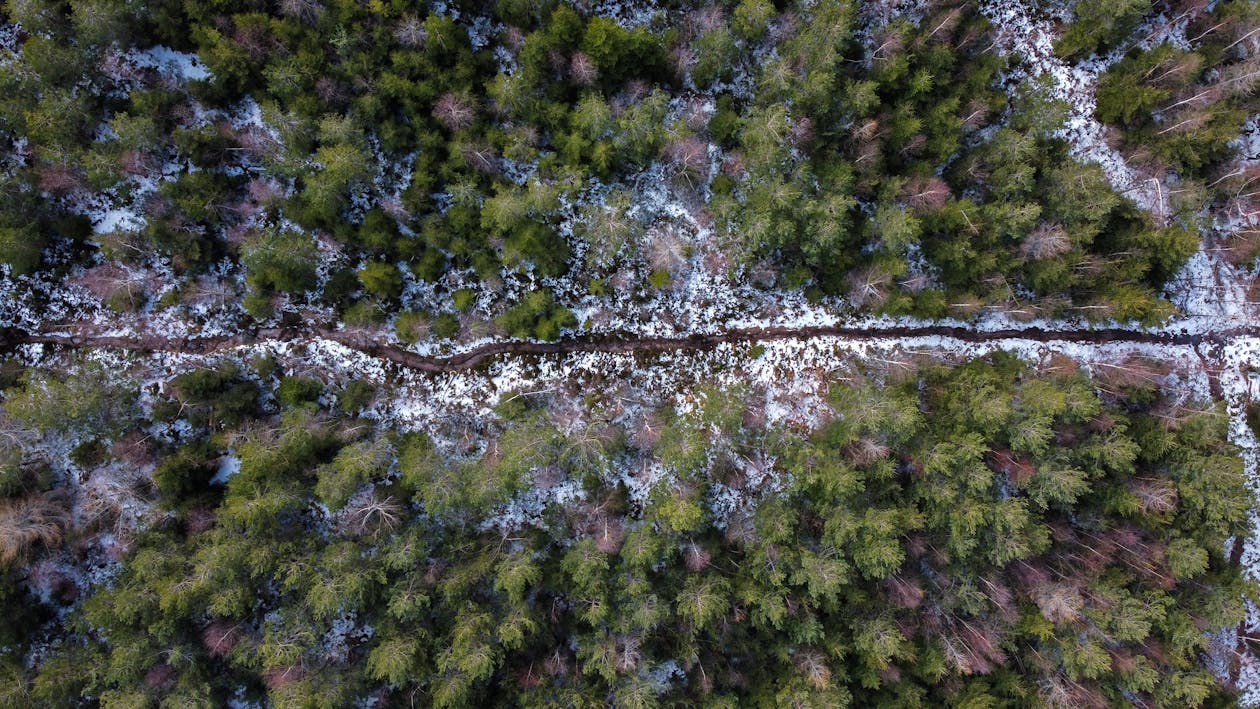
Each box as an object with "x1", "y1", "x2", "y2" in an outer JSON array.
[{"x1": 0, "y1": 354, "x2": 1251, "y2": 706}]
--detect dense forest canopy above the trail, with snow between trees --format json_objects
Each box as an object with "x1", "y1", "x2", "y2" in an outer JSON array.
[{"x1": 0, "y1": 0, "x2": 1260, "y2": 341}]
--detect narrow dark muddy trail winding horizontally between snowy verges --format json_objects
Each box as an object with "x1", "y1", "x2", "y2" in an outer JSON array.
[{"x1": 0, "y1": 325, "x2": 1260, "y2": 374}]
